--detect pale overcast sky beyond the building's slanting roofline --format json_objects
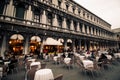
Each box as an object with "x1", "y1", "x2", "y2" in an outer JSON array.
[{"x1": 74, "y1": 0, "x2": 120, "y2": 29}]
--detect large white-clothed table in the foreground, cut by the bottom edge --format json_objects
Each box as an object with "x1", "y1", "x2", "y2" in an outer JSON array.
[{"x1": 34, "y1": 69, "x2": 54, "y2": 80}]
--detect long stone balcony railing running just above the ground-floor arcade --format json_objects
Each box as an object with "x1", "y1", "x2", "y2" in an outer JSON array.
[{"x1": 0, "y1": 15, "x2": 115, "y2": 40}]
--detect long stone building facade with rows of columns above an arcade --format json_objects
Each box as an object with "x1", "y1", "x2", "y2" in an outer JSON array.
[{"x1": 0, "y1": 0, "x2": 118, "y2": 56}]
